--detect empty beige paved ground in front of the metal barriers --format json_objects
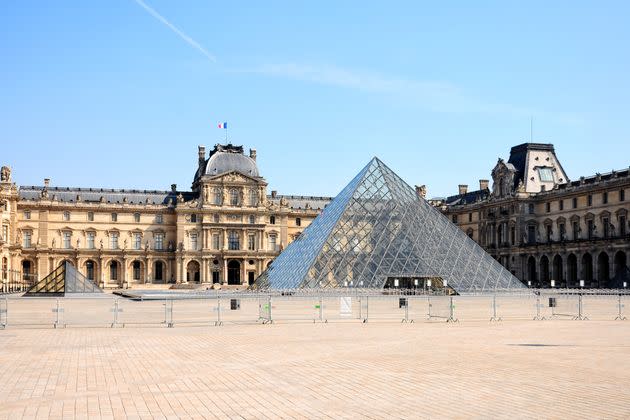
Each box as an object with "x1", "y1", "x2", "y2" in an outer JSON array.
[{"x1": 0, "y1": 320, "x2": 630, "y2": 418}]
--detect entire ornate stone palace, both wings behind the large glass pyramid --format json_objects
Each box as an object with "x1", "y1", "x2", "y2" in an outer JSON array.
[{"x1": 0, "y1": 143, "x2": 630, "y2": 288}]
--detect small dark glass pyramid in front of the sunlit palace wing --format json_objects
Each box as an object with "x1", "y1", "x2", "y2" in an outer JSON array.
[{"x1": 24, "y1": 261, "x2": 103, "y2": 296}]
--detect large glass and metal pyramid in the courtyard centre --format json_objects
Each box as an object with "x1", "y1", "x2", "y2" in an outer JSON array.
[{"x1": 252, "y1": 158, "x2": 525, "y2": 292}]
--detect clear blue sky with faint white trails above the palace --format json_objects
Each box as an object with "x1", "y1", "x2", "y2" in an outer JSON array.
[{"x1": 0, "y1": 0, "x2": 630, "y2": 196}]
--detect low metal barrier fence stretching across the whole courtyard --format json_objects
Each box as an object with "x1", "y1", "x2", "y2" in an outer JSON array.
[{"x1": 0, "y1": 291, "x2": 630, "y2": 328}]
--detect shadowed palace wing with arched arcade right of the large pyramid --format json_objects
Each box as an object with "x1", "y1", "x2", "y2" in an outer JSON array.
[{"x1": 440, "y1": 143, "x2": 630, "y2": 288}]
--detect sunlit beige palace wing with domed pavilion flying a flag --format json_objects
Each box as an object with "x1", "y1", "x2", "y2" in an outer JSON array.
[{"x1": 0, "y1": 145, "x2": 330, "y2": 288}]
